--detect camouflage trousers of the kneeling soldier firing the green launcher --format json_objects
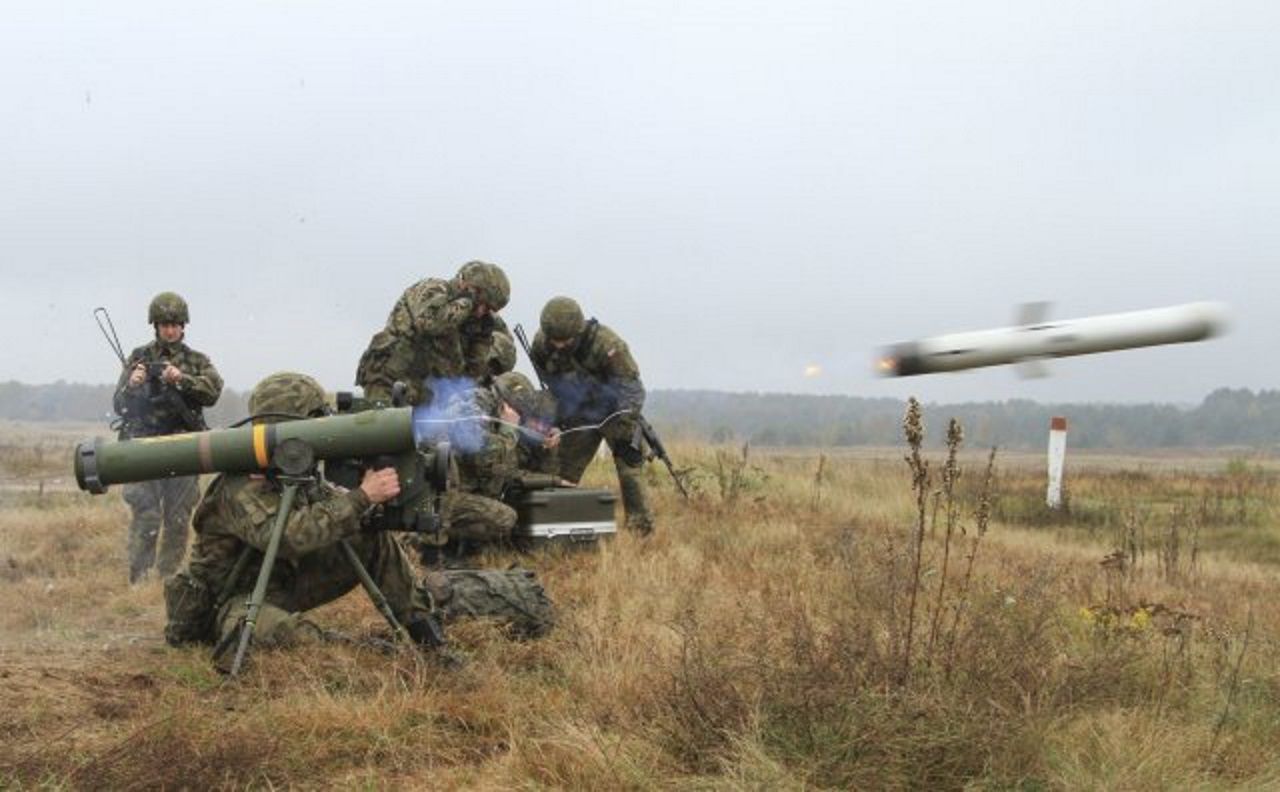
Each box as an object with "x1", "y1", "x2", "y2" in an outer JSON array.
[{"x1": 218, "y1": 531, "x2": 433, "y2": 646}]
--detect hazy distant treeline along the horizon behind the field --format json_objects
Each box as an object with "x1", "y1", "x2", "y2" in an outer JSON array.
[{"x1": 0, "y1": 381, "x2": 1280, "y2": 450}]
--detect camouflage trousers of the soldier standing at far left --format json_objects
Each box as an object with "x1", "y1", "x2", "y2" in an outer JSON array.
[{"x1": 124, "y1": 476, "x2": 200, "y2": 583}]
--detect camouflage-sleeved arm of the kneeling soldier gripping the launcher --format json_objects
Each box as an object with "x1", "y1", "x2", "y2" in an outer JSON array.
[{"x1": 225, "y1": 479, "x2": 370, "y2": 559}]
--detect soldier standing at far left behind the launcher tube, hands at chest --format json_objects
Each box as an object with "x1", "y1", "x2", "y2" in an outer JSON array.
[{"x1": 114, "y1": 292, "x2": 223, "y2": 582}]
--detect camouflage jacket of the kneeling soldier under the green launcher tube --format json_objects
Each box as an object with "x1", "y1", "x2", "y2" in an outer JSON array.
[{"x1": 188, "y1": 475, "x2": 370, "y2": 591}]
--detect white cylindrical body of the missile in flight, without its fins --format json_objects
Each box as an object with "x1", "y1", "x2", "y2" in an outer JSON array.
[{"x1": 879, "y1": 302, "x2": 1226, "y2": 376}]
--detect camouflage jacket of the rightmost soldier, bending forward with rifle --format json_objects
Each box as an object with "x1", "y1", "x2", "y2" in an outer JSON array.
[{"x1": 530, "y1": 320, "x2": 645, "y2": 438}]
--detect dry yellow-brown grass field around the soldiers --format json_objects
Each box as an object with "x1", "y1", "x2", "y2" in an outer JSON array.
[{"x1": 0, "y1": 416, "x2": 1280, "y2": 789}]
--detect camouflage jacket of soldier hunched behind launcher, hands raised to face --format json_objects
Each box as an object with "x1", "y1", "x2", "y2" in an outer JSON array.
[{"x1": 356, "y1": 278, "x2": 515, "y2": 404}]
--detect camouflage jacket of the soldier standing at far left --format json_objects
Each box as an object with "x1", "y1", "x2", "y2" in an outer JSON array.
[{"x1": 113, "y1": 339, "x2": 223, "y2": 438}]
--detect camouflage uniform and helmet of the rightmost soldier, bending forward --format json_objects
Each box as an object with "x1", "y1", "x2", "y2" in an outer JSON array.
[{"x1": 530, "y1": 297, "x2": 653, "y2": 534}]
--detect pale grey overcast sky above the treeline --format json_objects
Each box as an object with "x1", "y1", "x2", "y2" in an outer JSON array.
[{"x1": 0, "y1": 0, "x2": 1280, "y2": 402}]
